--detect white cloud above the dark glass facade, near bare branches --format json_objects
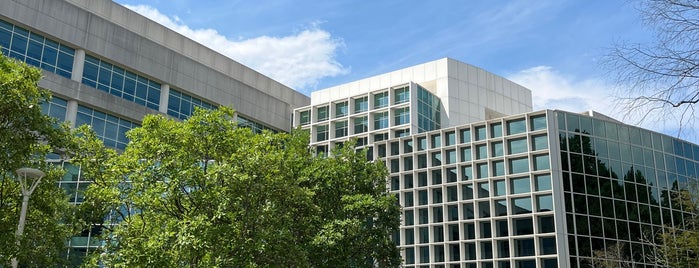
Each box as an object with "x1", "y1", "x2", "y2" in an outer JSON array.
[{"x1": 507, "y1": 66, "x2": 697, "y2": 141}]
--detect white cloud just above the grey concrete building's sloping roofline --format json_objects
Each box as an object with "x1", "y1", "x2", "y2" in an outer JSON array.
[{"x1": 126, "y1": 5, "x2": 348, "y2": 94}]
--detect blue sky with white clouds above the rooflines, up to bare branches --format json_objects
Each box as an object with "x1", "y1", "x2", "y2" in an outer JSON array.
[{"x1": 116, "y1": 0, "x2": 694, "y2": 139}]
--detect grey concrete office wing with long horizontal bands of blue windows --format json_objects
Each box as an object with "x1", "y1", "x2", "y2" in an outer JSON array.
[{"x1": 0, "y1": 0, "x2": 309, "y2": 263}]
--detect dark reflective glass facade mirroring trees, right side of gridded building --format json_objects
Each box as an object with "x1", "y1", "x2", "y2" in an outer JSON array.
[{"x1": 556, "y1": 112, "x2": 699, "y2": 267}]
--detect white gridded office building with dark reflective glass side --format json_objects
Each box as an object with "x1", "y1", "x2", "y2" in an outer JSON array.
[{"x1": 294, "y1": 63, "x2": 699, "y2": 268}]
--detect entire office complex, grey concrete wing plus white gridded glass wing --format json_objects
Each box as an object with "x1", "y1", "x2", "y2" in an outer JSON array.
[{"x1": 0, "y1": 0, "x2": 699, "y2": 268}]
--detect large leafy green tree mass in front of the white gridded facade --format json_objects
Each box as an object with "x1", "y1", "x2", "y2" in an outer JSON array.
[{"x1": 76, "y1": 107, "x2": 400, "y2": 267}]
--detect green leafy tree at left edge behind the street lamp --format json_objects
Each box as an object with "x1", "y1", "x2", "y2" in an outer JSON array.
[{"x1": 0, "y1": 51, "x2": 79, "y2": 267}]
